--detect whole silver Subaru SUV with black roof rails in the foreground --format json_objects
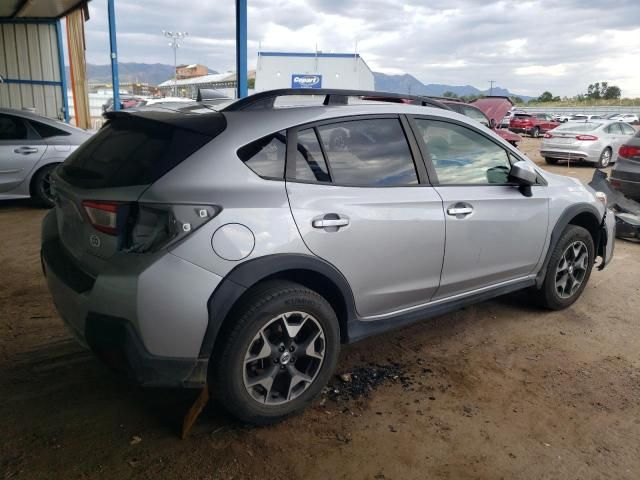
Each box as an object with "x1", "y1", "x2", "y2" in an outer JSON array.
[{"x1": 42, "y1": 90, "x2": 614, "y2": 424}]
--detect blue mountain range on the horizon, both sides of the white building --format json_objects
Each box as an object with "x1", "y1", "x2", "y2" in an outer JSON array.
[{"x1": 67, "y1": 63, "x2": 533, "y2": 101}]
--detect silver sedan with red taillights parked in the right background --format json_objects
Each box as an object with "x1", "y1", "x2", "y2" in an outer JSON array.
[{"x1": 540, "y1": 120, "x2": 636, "y2": 168}]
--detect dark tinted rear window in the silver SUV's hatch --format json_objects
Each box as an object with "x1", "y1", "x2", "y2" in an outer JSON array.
[{"x1": 61, "y1": 117, "x2": 212, "y2": 189}]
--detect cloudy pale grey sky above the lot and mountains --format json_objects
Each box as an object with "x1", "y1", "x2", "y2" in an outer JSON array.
[{"x1": 79, "y1": 0, "x2": 640, "y2": 97}]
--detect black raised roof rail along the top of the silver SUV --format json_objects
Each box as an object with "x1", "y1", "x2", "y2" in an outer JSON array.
[{"x1": 221, "y1": 88, "x2": 451, "y2": 112}]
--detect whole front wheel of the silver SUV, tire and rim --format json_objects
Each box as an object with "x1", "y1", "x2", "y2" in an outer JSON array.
[{"x1": 535, "y1": 225, "x2": 595, "y2": 310}]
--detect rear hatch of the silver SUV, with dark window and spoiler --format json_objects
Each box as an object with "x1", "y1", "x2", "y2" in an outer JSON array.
[{"x1": 53, "y1": 110, "x2": 226, "y2": 276}]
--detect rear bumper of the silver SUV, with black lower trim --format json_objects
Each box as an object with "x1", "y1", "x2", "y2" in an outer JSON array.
[{"x1": 41, "y1": 210, "x2": 221, "y2": 387}]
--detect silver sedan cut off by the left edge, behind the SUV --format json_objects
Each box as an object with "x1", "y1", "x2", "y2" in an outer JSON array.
[{"x1": 0, "y1": 108, "x2": 91, "y2": 207}]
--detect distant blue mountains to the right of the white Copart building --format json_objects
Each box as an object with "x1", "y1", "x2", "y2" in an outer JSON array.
[{"x1": 373, "y1": 72, "x2": 533, "y2": 101}]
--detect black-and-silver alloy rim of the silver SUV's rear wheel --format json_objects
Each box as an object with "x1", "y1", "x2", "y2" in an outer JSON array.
[{"x1": 243, "y1": 312, "x2": 326, "y2": 405}]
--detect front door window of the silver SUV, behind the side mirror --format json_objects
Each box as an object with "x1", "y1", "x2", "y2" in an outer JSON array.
[{"x1": 416, "y1": 119, "x2": 511, "y2": 185}]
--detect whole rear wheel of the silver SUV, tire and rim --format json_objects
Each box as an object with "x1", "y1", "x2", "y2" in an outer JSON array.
[{"x1": 209, "y1": 281, "x2": 340, "y2": 425}]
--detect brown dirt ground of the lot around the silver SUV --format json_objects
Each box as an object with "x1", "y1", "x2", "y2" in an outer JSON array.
[{"x1": 0, "y1": 139, "x2": 640, "y2": 480}]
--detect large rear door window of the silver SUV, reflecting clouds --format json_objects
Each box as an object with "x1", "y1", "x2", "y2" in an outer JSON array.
[{"x1": 318, "y1": 119, "x2": 418, "y2": 187}]
